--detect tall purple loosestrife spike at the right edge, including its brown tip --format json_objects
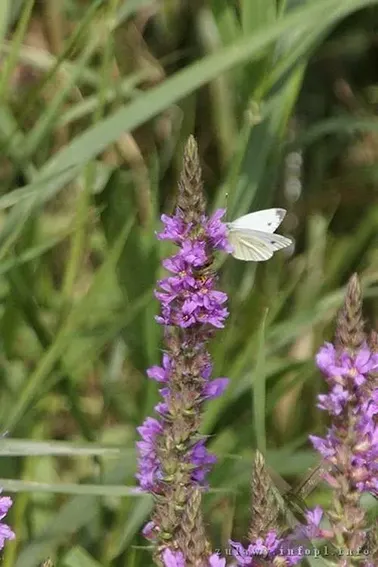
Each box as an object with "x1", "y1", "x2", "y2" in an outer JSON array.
[{"x1": 310, "y1": 275, "x2": 378, "y2": 565}]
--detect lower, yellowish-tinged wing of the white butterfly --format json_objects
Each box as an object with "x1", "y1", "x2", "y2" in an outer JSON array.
[{"x1": 228, "y1": 228, "x2": 292, "y2": 262}]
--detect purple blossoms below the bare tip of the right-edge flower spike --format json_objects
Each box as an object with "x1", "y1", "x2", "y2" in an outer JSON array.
[{"x1": 310, "y1": 343, "x2": 378, "y2": 496}]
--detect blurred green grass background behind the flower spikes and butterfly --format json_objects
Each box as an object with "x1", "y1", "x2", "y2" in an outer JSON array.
[{"x1": 0, "y1": 0, "x2": 378, "y2": 567}]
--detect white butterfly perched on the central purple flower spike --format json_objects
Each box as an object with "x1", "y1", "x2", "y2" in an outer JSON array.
[{"x1": 227, "y1": 209, "x2": 292, "y2": 262}]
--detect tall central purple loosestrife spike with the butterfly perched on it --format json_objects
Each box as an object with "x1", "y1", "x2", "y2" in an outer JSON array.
[{"x1": 137, "y1": 138, "x2": 230, "y2": 567}]
